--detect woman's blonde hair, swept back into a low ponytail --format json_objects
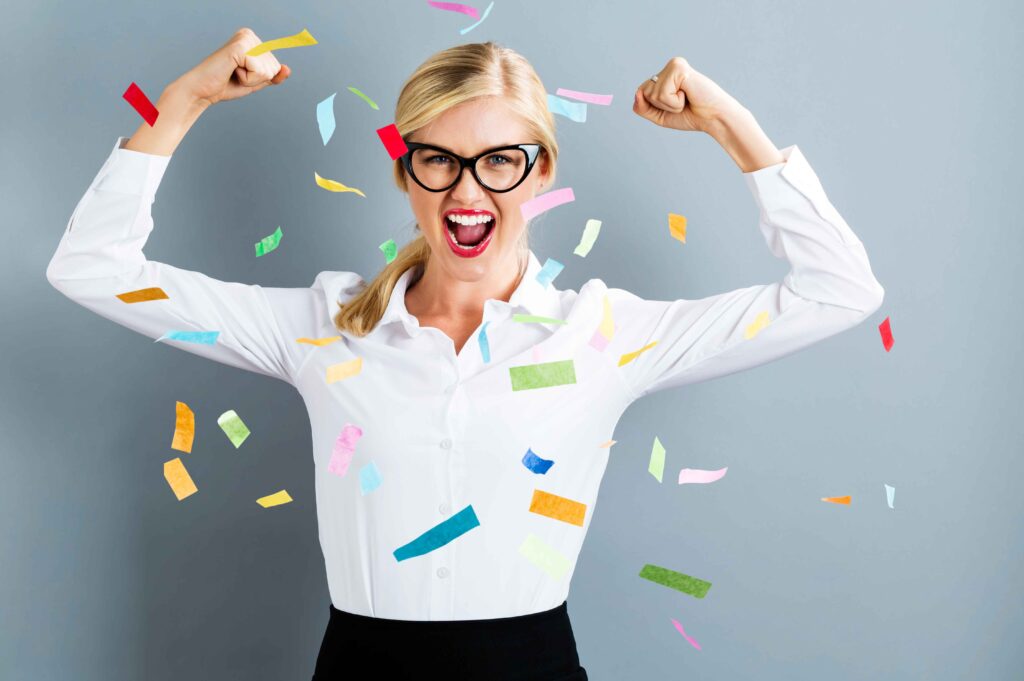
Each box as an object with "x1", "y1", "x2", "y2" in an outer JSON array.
[{"x1": 334, "y1": 42, "x2": 558, "y2": 336}]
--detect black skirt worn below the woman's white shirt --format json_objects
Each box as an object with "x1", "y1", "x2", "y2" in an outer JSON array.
[{"x1": 313, "y1": 602, "x2": 587, "y2": 681}]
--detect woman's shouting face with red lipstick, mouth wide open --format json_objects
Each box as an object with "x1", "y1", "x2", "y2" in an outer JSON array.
[{"x1": 406, "y1": 96, "x2": 548, "y2": 282}]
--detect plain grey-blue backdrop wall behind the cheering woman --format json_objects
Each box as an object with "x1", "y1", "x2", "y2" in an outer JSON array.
[{"x1": 0, "y1": 0, "x2": 1024, "y2": 681}]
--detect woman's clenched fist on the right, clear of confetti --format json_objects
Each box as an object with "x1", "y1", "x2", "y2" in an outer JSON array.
[{"x1": 633, "y1": 56, "x2": 742, "y2": 132}]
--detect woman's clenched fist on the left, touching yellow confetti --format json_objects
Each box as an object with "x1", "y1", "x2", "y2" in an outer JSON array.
[{"x1": 177, "y1": 29, "x2": 292, "y2": 105}]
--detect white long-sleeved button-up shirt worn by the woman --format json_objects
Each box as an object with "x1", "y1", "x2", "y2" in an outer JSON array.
[{"x1": 46, "y1": 137, "x2": 884, "y2": 620}]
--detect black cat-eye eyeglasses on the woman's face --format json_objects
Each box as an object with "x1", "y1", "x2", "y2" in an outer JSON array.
[{"x1": 401, "y1": 142, "x2": 542, "y2": 194}]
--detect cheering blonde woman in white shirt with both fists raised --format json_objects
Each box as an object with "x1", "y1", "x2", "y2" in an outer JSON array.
[{"x1": 47, "y1": 29, "x2": 883, "y2": 680}]
